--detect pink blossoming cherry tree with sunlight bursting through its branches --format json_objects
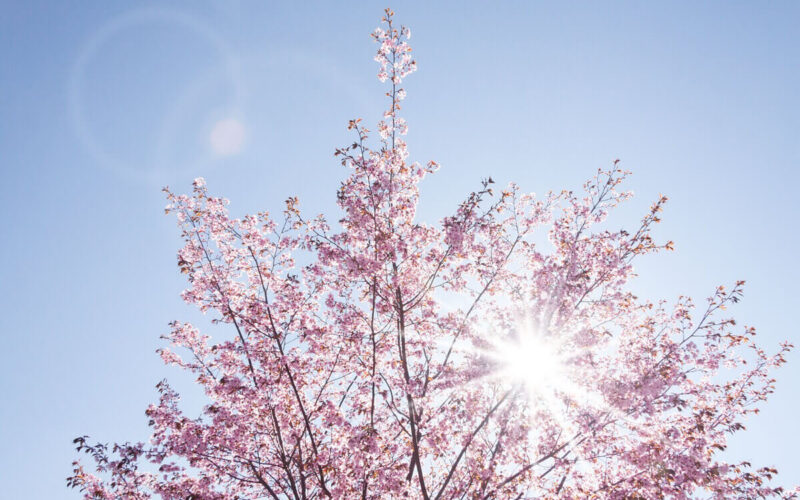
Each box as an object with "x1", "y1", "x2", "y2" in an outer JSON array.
[{"x1": 68, "y1": 10, "x2": 796, "y2": 500}]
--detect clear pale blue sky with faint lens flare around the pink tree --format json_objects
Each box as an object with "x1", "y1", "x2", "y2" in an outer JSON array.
[{"x1": 0, "y1": 1, "x2": 800, "y2": 499}]
